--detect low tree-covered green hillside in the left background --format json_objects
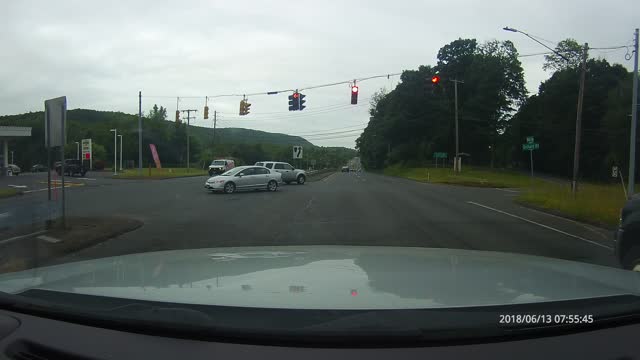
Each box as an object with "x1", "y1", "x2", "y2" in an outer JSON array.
[{"x1": 0, "y1": 109, "x2": 356, "y2": 168}]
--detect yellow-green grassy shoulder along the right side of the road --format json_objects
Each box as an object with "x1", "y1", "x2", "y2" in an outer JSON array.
[{"x1": 384, "y1": 166, "x2": 625, "y2": 227}]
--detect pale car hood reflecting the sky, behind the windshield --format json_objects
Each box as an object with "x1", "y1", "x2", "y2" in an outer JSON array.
[{"x1": 0, "y1": 246, "x2": 640, "y2": 309}]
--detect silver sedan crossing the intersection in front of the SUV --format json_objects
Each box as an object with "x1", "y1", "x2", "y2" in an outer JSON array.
[{"x1": 204, "y1": 166, "x2": 282, "y2": 194}]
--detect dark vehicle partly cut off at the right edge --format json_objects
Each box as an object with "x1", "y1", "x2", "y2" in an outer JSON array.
[{"x1": 614, "y1": 195, "x2": 640, "y2": 271}]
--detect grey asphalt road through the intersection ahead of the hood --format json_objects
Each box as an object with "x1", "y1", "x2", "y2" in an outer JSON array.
[{"x1": 0, "y1": 172, "x2": 617, "y2": 266}]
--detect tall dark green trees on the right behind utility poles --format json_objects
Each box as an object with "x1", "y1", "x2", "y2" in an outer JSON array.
[{"x1": 356, "y1": 39, "x2": 632, "y2": 180}]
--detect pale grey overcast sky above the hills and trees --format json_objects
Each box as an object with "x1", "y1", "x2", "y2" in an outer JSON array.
[{"x1": 0, "y1": 0, "x2": 640, "y2": 147}]
